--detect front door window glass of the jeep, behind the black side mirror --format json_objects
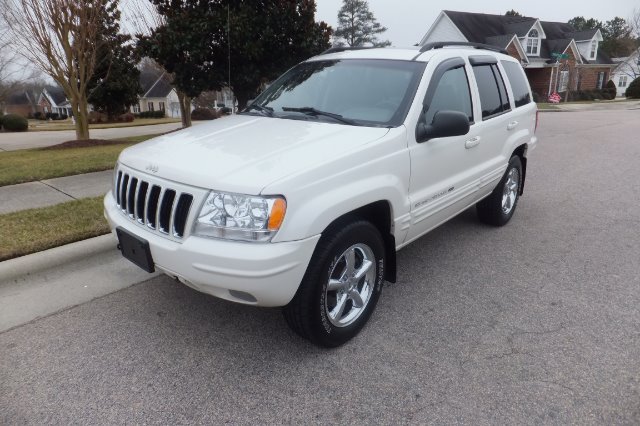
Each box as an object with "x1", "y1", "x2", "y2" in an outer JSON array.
[{"x1": 425, "y1": 67, "x2": 473, "y2": 124}]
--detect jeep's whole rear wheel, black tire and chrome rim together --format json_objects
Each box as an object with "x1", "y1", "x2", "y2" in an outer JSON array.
[{"x1": 476, "y1": 156, "x2": 522, "y2": 226}]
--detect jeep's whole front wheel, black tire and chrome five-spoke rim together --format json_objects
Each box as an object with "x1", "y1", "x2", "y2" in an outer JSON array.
[{"x1": 283, "y1": 220, "x2": 385, "y2": 347}]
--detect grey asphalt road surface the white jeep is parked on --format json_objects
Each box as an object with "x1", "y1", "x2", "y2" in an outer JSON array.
[{"x1": 0, "y1": 110, "x2": 640, "y2": 425}]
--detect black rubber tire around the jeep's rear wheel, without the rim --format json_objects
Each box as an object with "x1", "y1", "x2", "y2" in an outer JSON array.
[{"x1": 476, "y1": 155, "x2": 522, "y2": 226}]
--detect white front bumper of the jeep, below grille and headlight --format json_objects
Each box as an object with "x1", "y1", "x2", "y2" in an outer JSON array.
[{"x1": 104, "y1": 192, "x2": 320, "y2": 306}]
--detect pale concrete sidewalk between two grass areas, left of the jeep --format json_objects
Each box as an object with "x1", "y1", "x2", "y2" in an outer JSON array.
[{"x1": 0, "y1": 170, "x2": 113, "y2": 214}]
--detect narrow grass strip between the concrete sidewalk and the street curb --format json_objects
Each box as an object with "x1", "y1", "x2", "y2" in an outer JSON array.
[{"x1": 0, "y1": 197, "x2": 109, "y2": 261}]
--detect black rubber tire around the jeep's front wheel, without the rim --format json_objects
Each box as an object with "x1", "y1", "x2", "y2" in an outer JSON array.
[{"x1": 283, "y1": 219, "x2": 385, "y2": 347}]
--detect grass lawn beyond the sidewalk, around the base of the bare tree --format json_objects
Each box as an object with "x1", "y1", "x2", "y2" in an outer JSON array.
[{"x1": 0, "y1": 135, "x2": 158, "y2": 186}]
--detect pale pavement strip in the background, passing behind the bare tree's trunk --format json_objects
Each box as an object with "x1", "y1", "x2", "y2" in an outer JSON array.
[{"x1": 0, "y1": 123, "x2": 182, "y2": 151}]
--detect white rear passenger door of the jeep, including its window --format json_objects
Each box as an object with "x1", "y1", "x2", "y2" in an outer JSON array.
[{"x1": 469, "y1": 55, "x2": 518, "y2": 195}]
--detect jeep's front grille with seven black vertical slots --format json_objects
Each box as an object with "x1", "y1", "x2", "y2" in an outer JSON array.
[{"x1": 115, "y1": 170, "x2": 193, "y2": 238}]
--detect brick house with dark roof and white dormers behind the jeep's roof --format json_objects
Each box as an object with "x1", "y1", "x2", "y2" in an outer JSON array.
[{"x1": 420, "y1": 10, "x2": 617, "y2": 99}]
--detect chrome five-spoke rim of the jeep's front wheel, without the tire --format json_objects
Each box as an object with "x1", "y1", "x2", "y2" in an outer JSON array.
[{"x1": 325, "y1": 243, "x2": 376, "y2": 327}]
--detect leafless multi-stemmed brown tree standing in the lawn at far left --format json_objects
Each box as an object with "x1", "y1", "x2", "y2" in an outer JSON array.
[{"x1": 3, "y1": 0, "x2": 104, "y2": 139}]
